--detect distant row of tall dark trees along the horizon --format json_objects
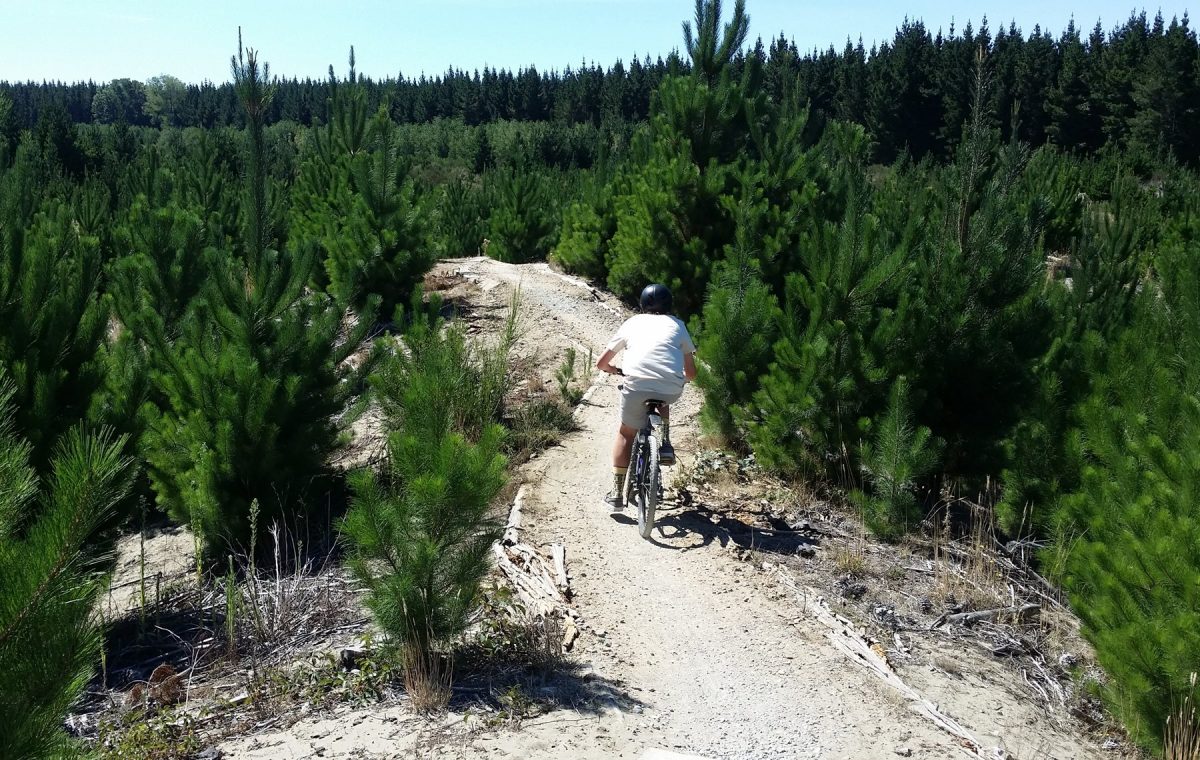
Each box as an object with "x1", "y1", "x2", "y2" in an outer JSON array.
[{"x1": 0, "y1": 8, "x2": 1200, "y2": 167}]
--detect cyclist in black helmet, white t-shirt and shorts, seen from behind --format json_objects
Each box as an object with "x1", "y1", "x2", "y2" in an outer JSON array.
[{"x1": 596, "y1": 285, "x2": 696, "y2": 510}]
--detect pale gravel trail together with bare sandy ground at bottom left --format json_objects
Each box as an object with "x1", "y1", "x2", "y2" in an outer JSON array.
[{"x1": 218, "y1": 259, "x2": 1091, "y2": 760}]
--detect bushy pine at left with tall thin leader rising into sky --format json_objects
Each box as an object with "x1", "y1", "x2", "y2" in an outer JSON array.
[{"x1": 136, "y1": 45, "x2": 374, "y2": 557}]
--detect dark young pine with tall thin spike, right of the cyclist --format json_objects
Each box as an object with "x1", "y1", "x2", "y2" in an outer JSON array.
[{"x1": 904, "y1": 53, "x2": 1052, "y2": 479}]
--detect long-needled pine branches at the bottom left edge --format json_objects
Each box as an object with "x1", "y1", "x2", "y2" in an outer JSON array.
[{"x1": 0, "y1": 383, "x2": 132, "y2": 759}]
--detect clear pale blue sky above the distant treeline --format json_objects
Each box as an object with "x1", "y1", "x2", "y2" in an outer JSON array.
[{"x1": 0, "y1": 0, "x2": 1188, "y2": 82}]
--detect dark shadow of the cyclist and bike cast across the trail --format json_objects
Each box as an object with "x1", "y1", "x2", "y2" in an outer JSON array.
[{"x1": 612, "y1": 503, "x2": 821, "y2": 556}]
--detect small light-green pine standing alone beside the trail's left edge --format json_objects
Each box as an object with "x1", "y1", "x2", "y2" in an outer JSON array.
[{"x1": 342, "y1": 322, "x2": 505, "y2": 687}]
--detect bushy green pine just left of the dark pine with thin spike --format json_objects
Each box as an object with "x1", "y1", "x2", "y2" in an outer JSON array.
[{"x1": 749, "y1": 145, "x2": 924, "y2": 478}]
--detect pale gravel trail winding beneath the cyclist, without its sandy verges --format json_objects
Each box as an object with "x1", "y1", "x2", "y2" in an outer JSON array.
[{"x1": 446, "y1": 262, "x2": 961, "y2": 758}]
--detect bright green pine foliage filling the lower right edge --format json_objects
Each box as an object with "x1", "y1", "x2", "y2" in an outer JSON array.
[{"x1": 1051, "y1": 233, "x2": 1200, "y2": 749}]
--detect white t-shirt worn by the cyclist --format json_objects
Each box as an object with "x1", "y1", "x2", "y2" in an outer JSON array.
[{"x1": 607, "y1": 315, "x2": 696, "y2": 393}]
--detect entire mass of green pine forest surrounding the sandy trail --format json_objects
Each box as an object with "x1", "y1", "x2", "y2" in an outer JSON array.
[{"x1": 0, "y1": 0, "x2": 1200, "y2": 754}]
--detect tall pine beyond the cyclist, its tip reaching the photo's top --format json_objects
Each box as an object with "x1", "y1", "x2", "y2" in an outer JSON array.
[{"x1": 558, "y1": 0, "x2": 766, "y2": 318}]
